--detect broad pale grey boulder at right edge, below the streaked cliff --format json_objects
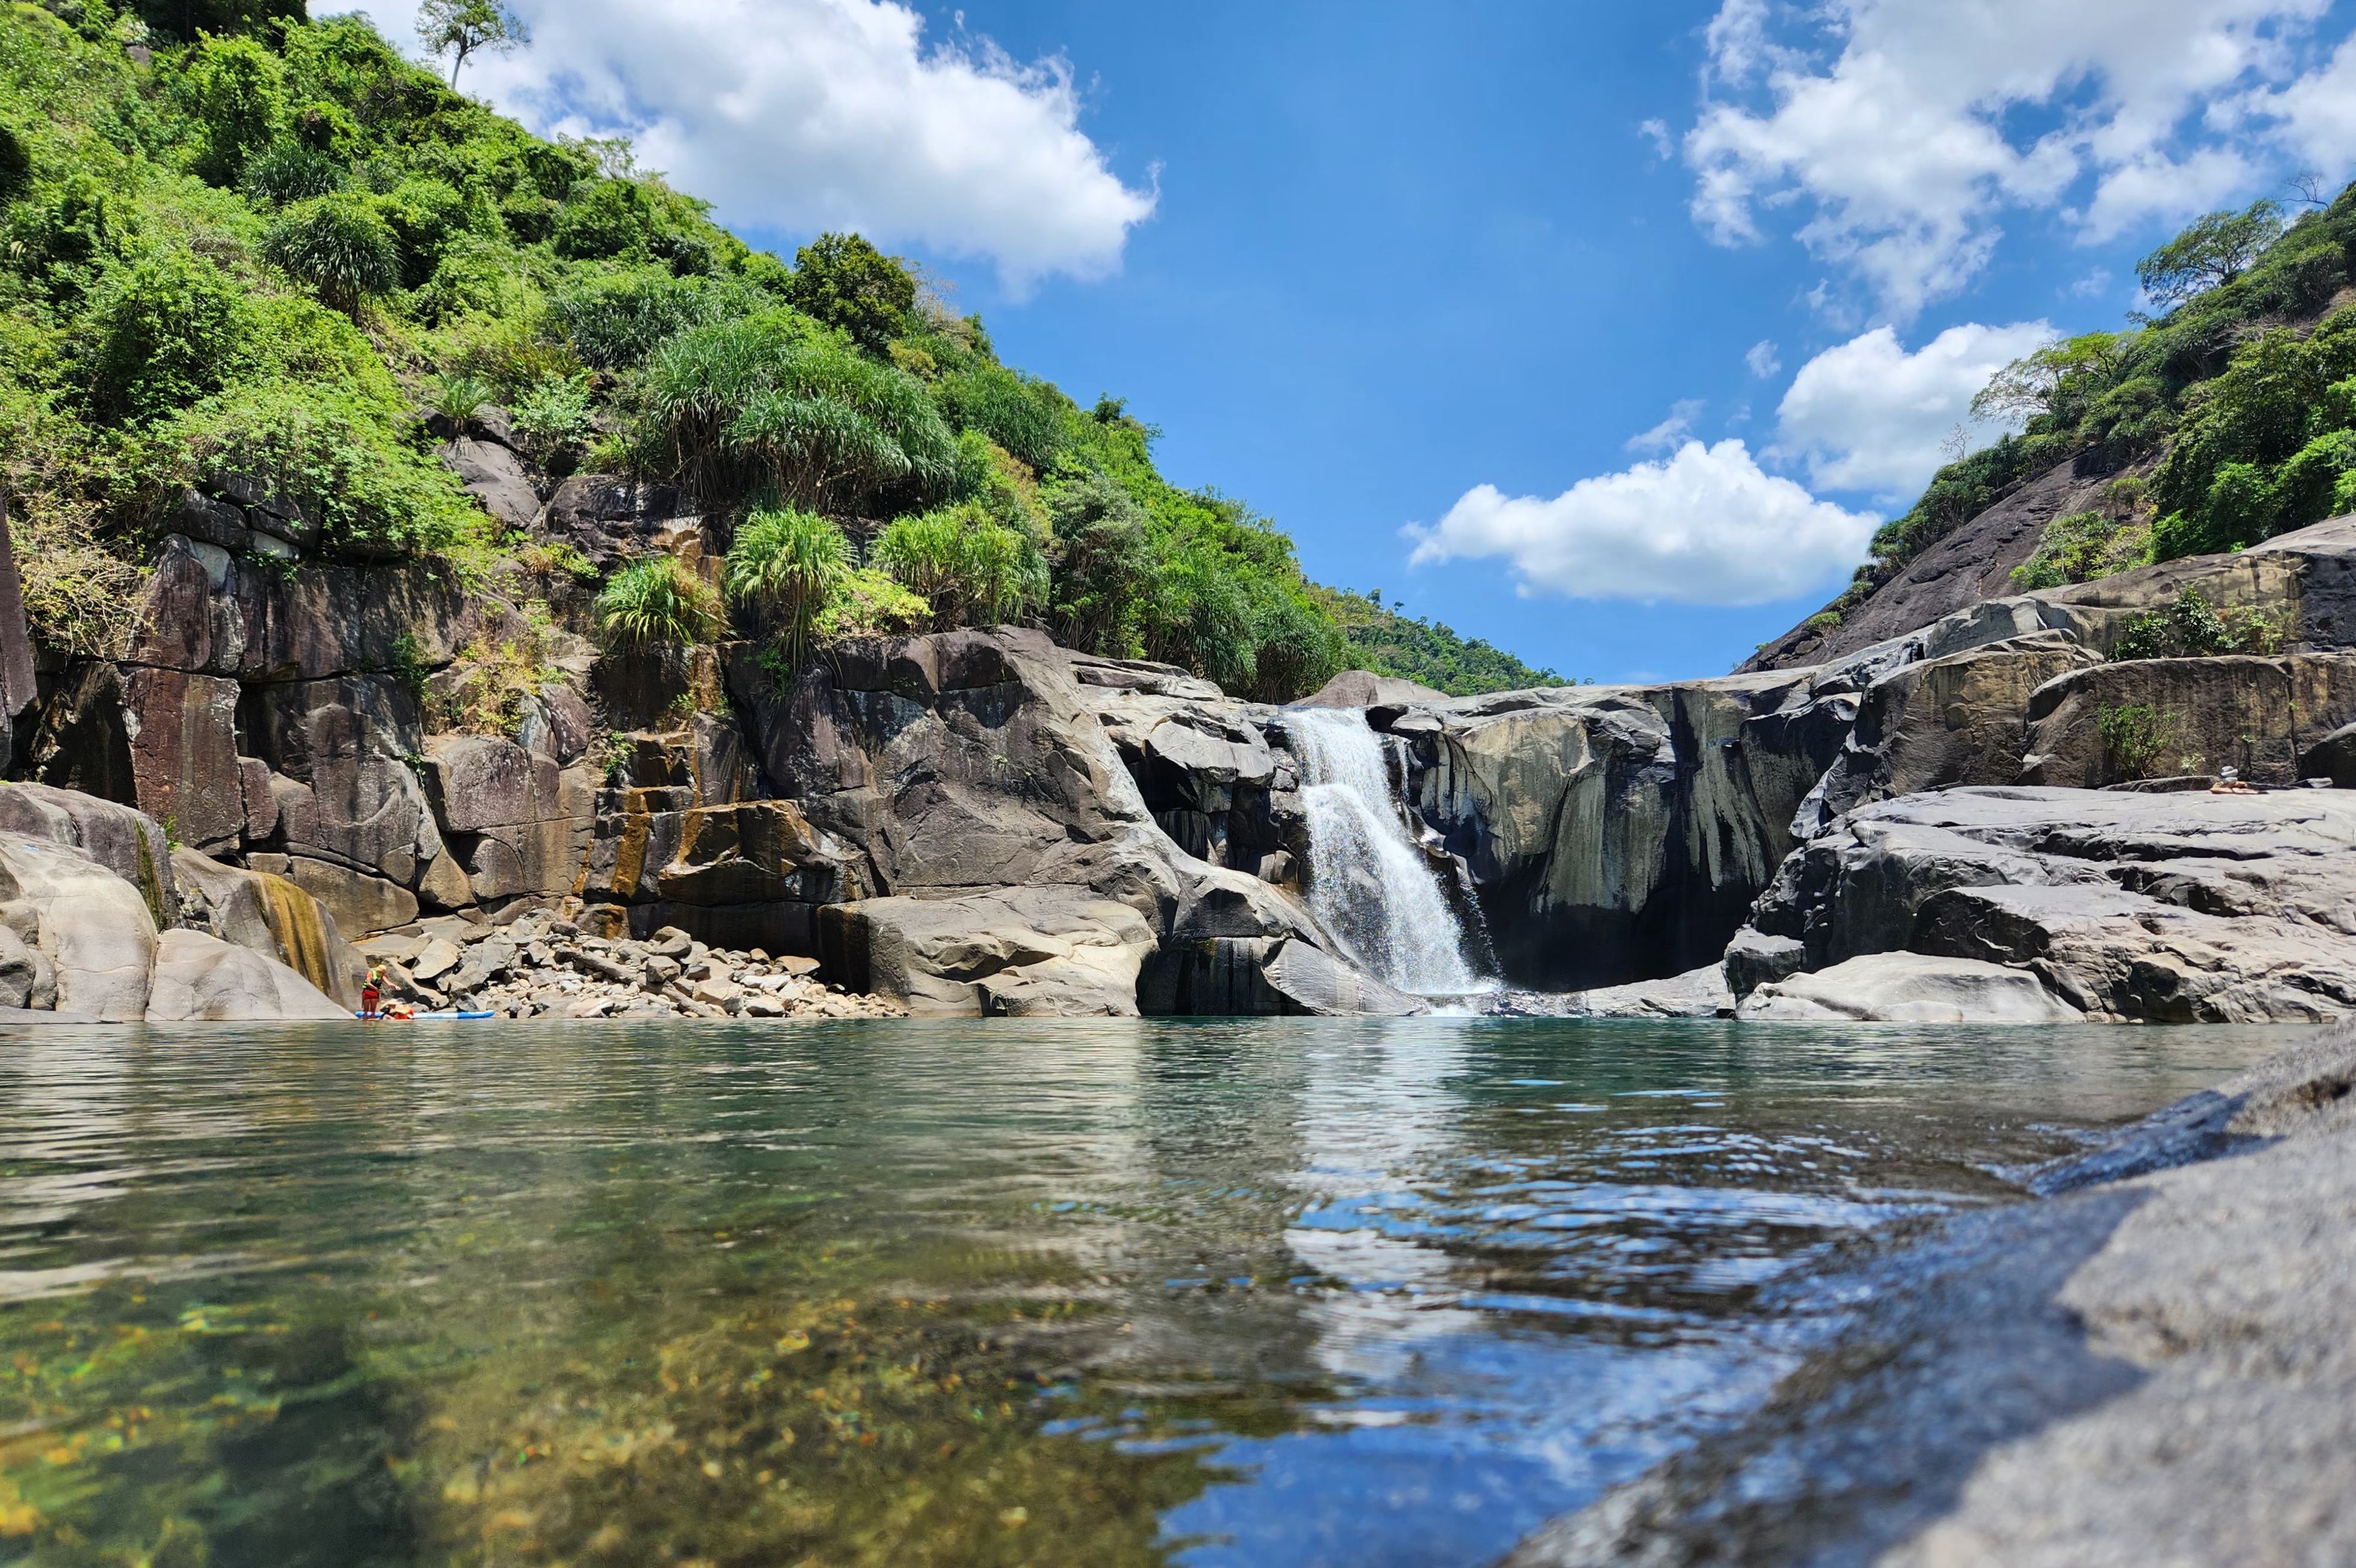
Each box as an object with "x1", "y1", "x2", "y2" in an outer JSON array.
[{"x1": 1727, "y1": 788, "x2": 2356, "y2": 1022}]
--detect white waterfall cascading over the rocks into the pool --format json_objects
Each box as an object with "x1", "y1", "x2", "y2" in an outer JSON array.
[{"x1": 1284, "y1": 708, "x2": 1487, "y2": 996}]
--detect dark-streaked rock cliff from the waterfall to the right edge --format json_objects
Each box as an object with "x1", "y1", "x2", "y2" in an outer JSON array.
[{"x1": 1369, "y1": 518, "x2": 2356, "y2": 994}]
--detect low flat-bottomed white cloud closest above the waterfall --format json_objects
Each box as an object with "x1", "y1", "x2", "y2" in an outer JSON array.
[{"x1": 1406, "y1": 440, "x2": 1878, "y2": 605}]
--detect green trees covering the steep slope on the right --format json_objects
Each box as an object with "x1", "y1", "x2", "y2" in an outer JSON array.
[{"x1": 1833, "y1": 186, "x2": 2356, "y2": 610}]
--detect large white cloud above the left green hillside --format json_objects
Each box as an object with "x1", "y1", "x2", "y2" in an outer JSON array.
[{"x1": 344, "y1": 0, "x2": 1155, "y2": 292}]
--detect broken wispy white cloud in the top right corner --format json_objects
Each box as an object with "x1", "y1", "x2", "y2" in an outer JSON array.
[{"x1": 1684, "y1": 0, "x2": 2356, "y2": 320}]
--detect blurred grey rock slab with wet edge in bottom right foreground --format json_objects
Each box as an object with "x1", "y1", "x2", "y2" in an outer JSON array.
[{"x1": 1508, "y1": 1026, "x2": 2356, "y2": 1568}]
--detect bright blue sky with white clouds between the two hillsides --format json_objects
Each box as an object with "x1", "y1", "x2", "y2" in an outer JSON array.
[{"x1": 349, "y1": 0, "x2": 2356, "y2": 680}]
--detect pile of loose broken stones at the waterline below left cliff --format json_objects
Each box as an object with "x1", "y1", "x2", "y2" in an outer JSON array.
[{"x1": 358, "y1": 911, "x2": 907, "y2": 1019}]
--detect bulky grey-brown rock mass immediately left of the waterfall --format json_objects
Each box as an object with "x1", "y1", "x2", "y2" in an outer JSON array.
[{"x1": 730, "y1": 629, "x2": 1418, "y2": 1014}]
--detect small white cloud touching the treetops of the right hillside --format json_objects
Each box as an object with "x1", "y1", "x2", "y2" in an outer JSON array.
[{"x1": 1774, "y1": 320, "x2": 2059, "y2": 499}]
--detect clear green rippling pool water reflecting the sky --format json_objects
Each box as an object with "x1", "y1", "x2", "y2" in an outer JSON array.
[{"x1": 0, "y1": 1019, "x2": 2283, "y2": 1568}]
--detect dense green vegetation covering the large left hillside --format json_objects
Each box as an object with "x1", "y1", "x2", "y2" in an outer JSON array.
[{"x1": 0, "y1": 0, "x2": 1564, "y2": 702}]
